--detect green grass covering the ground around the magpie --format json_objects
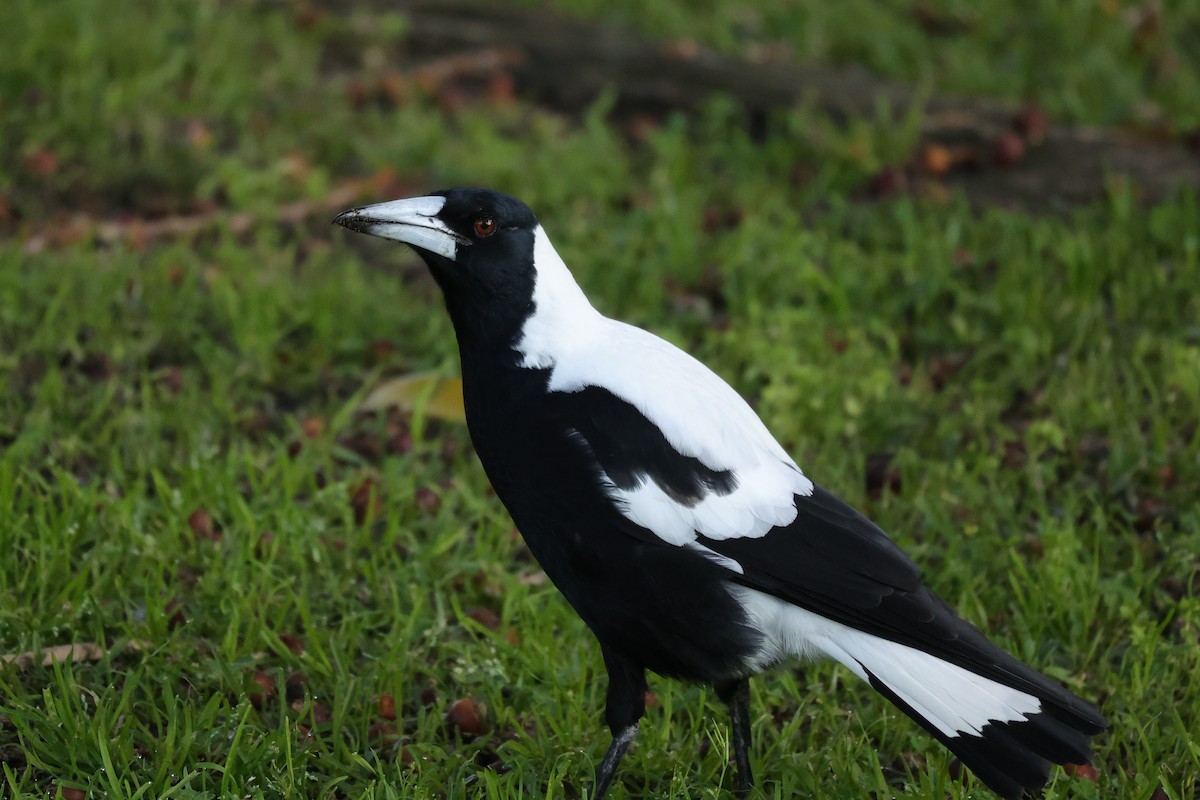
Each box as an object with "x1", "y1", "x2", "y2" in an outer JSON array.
[{"x1": 0, "y1": 0, "x2": 1200, "y2": 800}]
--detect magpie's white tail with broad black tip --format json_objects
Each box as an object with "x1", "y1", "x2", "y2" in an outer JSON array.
[{"x1": 822, "y1": 622, "x2": 1108, "y2": 800}]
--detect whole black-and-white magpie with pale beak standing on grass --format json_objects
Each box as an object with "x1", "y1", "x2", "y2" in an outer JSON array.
[{"x1": 335, "y1": 188, "x2": 1106, "y2": 798}]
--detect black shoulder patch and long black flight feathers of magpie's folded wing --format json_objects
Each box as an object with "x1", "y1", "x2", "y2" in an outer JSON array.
[{"x1": 546, "y1": 386, "x2": 1105, "y2": 733}]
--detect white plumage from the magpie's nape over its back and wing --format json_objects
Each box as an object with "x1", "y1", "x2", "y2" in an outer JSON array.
[{"x1": 517, "y1": 227, "x2": 812, "y2": 551}]
